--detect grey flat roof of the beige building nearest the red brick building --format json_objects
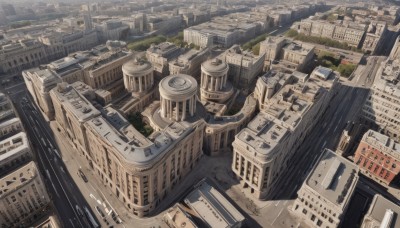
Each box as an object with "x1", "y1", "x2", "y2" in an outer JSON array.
[{"x1": 303, "y1": 149, "x2": 358, "y2": 208}]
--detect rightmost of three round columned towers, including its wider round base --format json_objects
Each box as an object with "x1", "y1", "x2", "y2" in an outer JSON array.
[{"x1": 200, "y1": 59, "x2": 233, "y2": 103}]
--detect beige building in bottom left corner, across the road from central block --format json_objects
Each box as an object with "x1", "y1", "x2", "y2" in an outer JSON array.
[{"x1": 0, "y1": 162, "x2": 50, "y2": 227}]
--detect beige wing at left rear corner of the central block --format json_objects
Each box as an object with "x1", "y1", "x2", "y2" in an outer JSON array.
[{"x1": 22, "y1": 45, "x2": 132, "y2": 120}]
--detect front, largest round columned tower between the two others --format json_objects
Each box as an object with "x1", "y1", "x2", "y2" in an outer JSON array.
[{"x1": 159, "y1": 74, "x2": 197, "y2": 121}]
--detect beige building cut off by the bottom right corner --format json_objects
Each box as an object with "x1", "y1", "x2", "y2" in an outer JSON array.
[{"x1": 361, "y1": 195, "x2": 400, "y2": 228}]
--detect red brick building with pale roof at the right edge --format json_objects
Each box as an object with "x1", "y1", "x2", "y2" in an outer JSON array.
[{"x1": 354, "y1": 130, "x2": 400, "y2": 185}]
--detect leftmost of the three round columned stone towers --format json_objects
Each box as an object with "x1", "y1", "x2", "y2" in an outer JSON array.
[{"x1": 122, "y1": 59, "x2": 154, "y2": 93}]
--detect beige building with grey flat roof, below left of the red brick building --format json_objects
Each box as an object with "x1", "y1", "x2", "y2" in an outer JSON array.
[{"x1": 292, "y1": 149, "x2": 358, "y2": 228}]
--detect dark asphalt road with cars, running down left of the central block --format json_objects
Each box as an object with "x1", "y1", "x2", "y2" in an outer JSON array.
[{"x1": 11, "y1": 91, "x2": 98, "y2": 228}]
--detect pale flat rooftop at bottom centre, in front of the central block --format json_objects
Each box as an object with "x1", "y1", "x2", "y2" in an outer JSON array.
[{"x1": 185, "y1": 181, "x2": 245, "y2": 227}]
